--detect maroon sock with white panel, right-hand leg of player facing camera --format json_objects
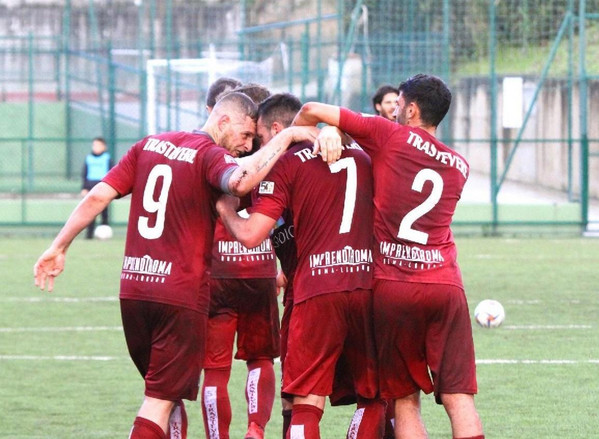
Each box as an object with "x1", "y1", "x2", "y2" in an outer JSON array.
[{"x1": 245, "y1": 360, "x2": 275, "y2": 428}]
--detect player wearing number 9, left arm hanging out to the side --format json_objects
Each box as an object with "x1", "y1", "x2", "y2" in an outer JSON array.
[{"x1": 34, "y1": 93, "x2": 317, "y2": 439}]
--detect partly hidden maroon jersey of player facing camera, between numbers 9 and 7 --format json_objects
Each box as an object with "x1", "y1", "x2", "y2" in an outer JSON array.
[{"x1": 210, "y1": 191, "x2": 277, "y2": 279}]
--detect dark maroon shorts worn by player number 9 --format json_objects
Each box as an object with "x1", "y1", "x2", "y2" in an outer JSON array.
[{"x1": 121, "y1": 299, "x2": 208, "y2": 401}]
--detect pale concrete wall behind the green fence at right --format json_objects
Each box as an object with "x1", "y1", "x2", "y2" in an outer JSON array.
[{"x1": 450, "y1": 78, "x2": 599, "y2": 198}]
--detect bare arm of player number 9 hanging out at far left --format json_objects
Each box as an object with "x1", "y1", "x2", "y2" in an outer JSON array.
[{"x1": 33, "y1": 182, "x2": 118, "y2": 291}]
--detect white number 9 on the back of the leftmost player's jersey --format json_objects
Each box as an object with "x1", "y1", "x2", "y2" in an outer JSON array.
[{"x1": 137, "y1": 165, "x2": 173, "y2": 239}]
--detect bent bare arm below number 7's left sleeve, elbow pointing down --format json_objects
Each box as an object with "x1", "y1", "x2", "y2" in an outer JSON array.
[{"x1": 216, "y1": 195, "x2": 277, "y2": 248}]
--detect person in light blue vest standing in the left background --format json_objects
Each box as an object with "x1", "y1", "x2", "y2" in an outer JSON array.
[{"x1": 81, "y1": 137, "x2": 113, "y2": 239}]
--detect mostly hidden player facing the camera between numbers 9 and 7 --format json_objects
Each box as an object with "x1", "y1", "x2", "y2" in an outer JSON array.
[{"x1": 201, "y1": 81, "x2": 284, "y2": 439}]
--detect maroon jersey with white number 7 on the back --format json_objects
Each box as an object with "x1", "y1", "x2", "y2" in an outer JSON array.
[{"x1": 253, "y1": 142, "x2": 373, "y2": 303}]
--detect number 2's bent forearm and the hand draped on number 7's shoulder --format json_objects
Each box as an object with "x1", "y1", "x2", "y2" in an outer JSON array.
[{"x1": 293, "y1": 102, "x2": 344, "y2": 164}]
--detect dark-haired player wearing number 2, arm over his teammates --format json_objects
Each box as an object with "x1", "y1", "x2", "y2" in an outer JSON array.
[{"x1": 294, "y1": 74, "x2": 484, "y2": 439}]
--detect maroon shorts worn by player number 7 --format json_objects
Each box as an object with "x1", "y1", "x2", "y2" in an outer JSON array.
[{"x1": 283, "y1": 290, "x2": 378, "y2": 398}]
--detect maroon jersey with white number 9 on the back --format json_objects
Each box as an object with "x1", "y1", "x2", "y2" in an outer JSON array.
[{"x1": 103, "y1": 132, "x2": 237, "y2": 313}]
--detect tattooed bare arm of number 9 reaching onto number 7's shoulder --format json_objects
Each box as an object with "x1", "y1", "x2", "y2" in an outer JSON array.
[{"x1": 225, "y1": 126, "x2": 319, "y2": 196}]
